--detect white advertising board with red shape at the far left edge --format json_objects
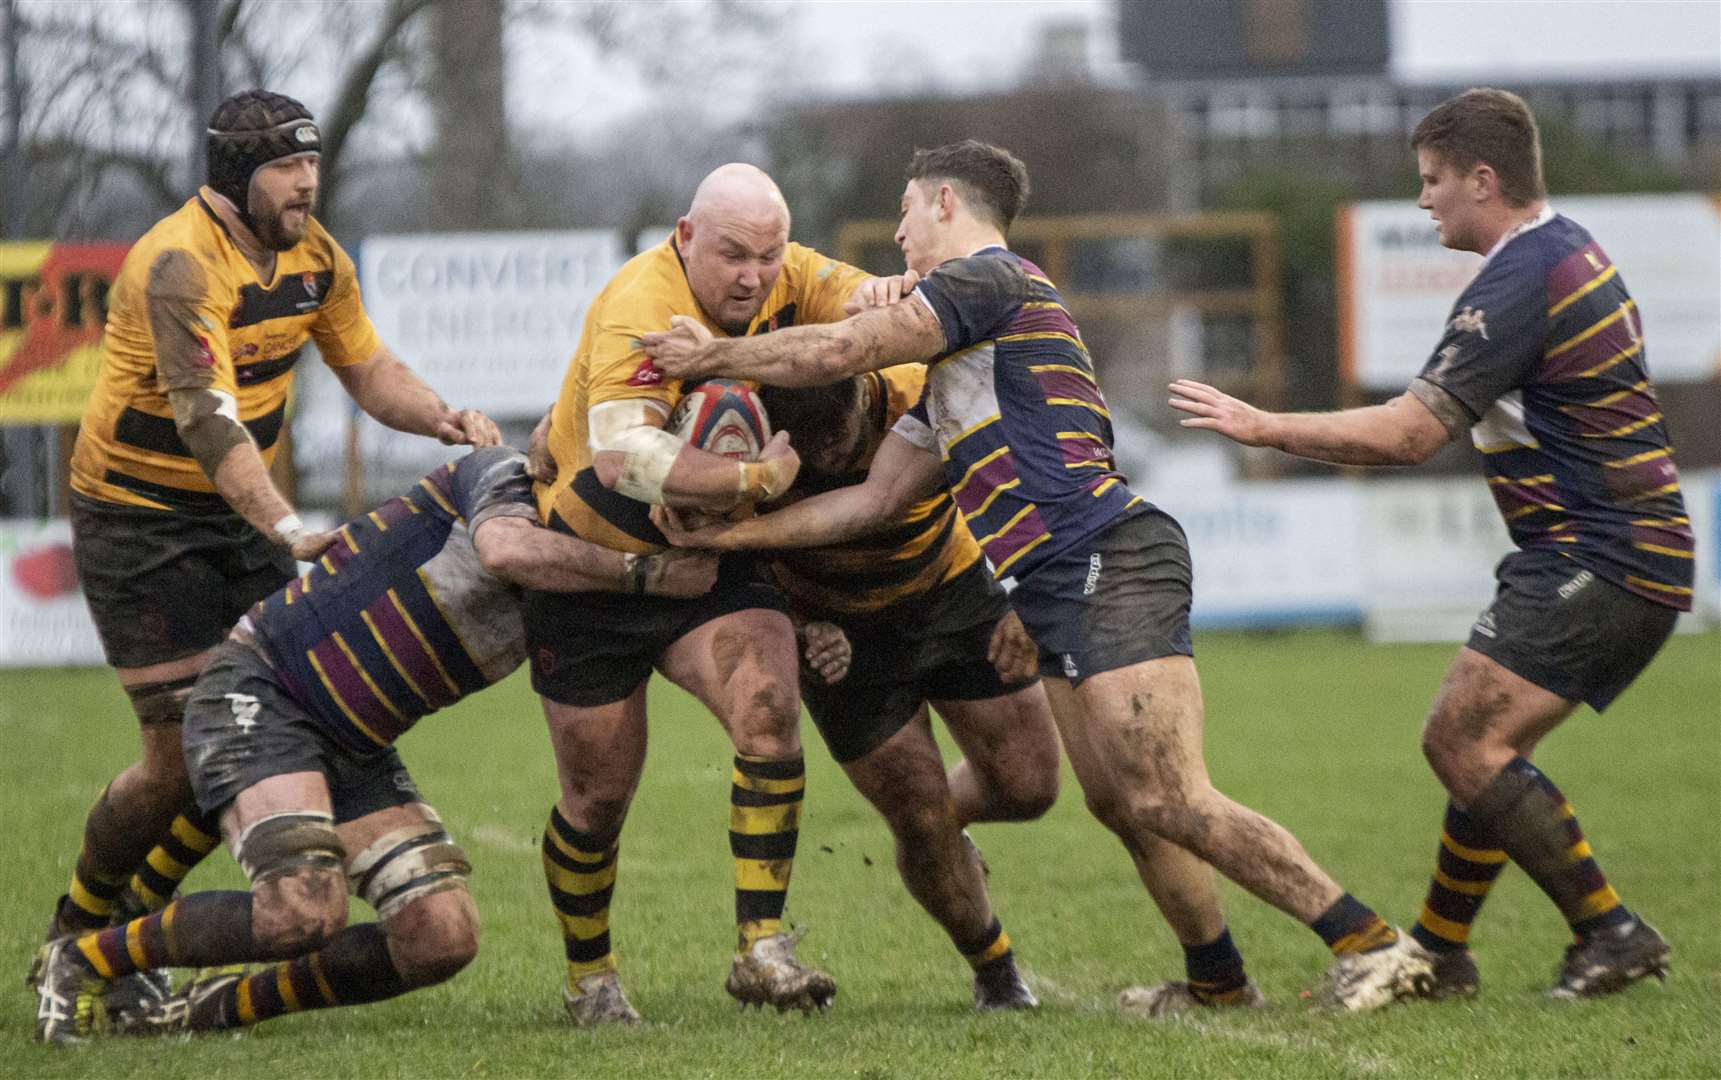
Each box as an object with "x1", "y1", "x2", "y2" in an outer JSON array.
[{"x1": 0, "y1": 519, "x2": 103, "y2": 667}]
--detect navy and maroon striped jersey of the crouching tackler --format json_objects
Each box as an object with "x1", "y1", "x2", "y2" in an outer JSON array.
[{"x1": 246, "y1": 447, "x2": 537, "y2": 753}]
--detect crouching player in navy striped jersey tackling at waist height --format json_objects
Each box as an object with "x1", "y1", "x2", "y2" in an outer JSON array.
[{"x1": 36, "y1": 447, "x2": 716, "y2": 1042}]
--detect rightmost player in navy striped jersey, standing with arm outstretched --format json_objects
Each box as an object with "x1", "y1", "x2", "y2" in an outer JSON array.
[{"x1": 1172, "y1": 89, "x2": 1693, "y2": 997}]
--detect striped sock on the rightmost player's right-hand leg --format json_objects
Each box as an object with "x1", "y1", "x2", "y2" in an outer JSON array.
[{"x1": 1470, "y1": 757, "x2": 1632, "y2": 937}]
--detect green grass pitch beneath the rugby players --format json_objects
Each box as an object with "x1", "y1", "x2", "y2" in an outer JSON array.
[{"x1": 0, "y1": 633, "x2": 1721, "y2": 1080}]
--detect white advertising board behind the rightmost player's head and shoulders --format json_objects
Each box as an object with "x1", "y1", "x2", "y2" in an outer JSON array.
[{"x1": 1339, "y1": 194, "x2": 1721, "y2": 390}]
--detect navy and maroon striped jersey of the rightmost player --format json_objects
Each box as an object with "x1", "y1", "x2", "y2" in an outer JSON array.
[{"x1": 1418, "y1": 210, "x2": 1695, "y2": 611}]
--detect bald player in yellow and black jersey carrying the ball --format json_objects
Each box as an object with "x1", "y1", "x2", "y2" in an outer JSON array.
[{"x1": 527, "y1": 165, "x2": 902, "y2": 1025}]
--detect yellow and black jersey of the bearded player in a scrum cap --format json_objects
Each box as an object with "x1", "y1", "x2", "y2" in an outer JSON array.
[{"x1": 72, "y1": 187, "x2": 382, "y2": 514}]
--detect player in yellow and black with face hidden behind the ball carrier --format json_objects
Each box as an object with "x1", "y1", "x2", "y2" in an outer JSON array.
[{"x1": 761, "y1": 365, "x2": 1058, "y2": 1011}]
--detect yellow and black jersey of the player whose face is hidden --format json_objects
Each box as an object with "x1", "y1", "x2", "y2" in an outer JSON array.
[{"x1": 766, "y1": 365, "x2": 979, "y2": 617}]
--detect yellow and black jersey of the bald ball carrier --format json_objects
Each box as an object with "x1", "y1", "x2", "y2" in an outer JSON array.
[{"x1": 537, "y1": 236, "x2": 867, "y2": 554}]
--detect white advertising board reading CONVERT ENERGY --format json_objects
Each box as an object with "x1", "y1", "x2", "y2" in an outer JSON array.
[{"x1": 358, "y1": 229, "x2": 626, "y2": 420}]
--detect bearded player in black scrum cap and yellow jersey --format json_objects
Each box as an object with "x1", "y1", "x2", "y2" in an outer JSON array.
[{"x1": 35, "y1": 89, "x2": 499, "y2": 997}]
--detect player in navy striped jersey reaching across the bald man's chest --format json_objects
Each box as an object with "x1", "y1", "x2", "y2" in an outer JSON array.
[{"x1": 645, "y1": 141, "x2": 1430, "y2": 1015}]
